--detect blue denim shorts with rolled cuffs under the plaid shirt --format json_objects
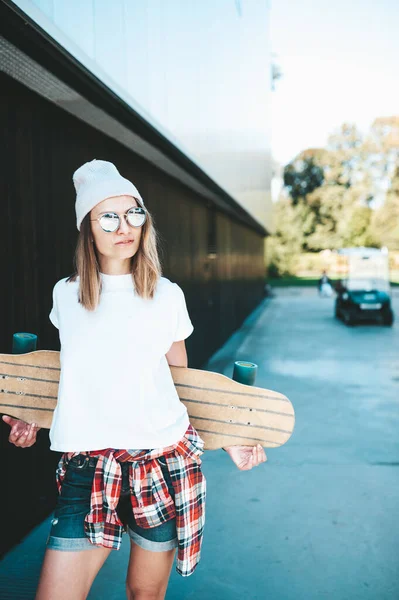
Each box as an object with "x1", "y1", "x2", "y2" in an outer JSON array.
[{"x1": 47, "y1": 454, "x2": 177, "y2": 552}]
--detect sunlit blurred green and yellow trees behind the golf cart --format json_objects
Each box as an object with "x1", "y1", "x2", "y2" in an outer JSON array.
[{"x1": 269, "y1": 117, "x2": 399, "y2": 274}]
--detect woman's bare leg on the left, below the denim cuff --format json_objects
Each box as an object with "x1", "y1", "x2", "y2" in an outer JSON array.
[{"x1": 36, "y1": 547, "x2": 111, "y2": 600}]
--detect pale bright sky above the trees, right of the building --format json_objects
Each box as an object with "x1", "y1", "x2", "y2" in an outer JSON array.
[{"x1": 270, "y1": 0, "x2": 399, "y2": 164}]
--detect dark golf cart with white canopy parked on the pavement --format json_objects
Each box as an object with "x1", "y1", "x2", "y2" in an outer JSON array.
[{"x1": 335, "y1": 248, "x2": 394, "y2": 326}]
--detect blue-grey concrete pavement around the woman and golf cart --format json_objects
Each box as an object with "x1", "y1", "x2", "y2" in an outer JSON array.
[{"x1": 0, "y1": 289, "x2": 399, "y2": 600}]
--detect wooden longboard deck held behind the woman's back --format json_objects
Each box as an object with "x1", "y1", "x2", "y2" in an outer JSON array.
[{"x1": 0, "y1": 350, "x2": 295, "y2": 450}]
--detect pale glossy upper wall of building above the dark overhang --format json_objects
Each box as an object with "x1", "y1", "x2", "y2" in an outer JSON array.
[{"x1": 11, "y1": 0, "x2": 271, "y2": 227}]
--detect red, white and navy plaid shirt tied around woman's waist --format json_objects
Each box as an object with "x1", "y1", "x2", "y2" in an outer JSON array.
[{"x1": 56, "y1": 425, "x2": 206, "y2": 577}]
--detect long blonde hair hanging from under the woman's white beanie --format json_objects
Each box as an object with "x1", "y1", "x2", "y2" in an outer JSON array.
[{"x1": 68, "y1": 205, "x2": 162, "y2": 310}]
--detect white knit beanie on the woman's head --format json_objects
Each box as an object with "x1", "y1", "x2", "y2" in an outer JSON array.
[{"x1": 73, "y1": 160, "x2": 144, "y2": 230}]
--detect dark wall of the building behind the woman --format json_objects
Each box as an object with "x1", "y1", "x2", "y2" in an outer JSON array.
[{"x1": 0, "y1": 74, "x2": 264, "y2": 550}]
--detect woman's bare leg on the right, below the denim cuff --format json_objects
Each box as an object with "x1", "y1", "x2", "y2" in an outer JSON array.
[{"x1": 125, "y1": 540, "x2": 176, "y2": 600}]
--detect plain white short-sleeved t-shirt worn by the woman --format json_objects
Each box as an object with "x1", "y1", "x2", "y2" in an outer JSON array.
[{"x1": 50, "y1": 274, "x2": 193, "y2": 452}]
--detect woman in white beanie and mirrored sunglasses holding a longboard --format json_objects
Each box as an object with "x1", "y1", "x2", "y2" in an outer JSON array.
[{"x1": 3, "y1": 160, "x2": 266, "y2": 600}]
